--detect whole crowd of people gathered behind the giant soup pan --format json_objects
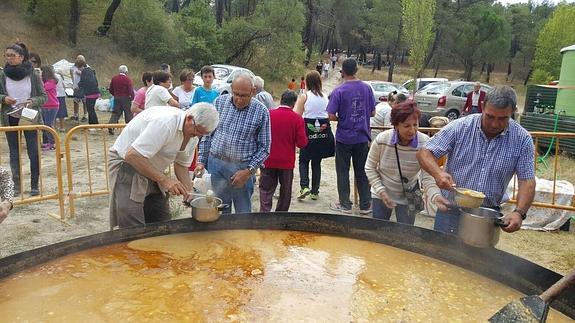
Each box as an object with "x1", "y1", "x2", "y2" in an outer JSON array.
[{"x1": 0, "y1": 43, "x2": 535, "y2": 238}]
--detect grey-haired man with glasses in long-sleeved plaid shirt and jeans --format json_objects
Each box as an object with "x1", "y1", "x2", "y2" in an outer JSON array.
[{"x1": 195, "y1": 72, "x2": 271, "y2": 213}]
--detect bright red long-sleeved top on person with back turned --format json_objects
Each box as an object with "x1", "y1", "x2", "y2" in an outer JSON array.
[{"x1": 264, "y1": 105, "x2": 307, "y2": 169}]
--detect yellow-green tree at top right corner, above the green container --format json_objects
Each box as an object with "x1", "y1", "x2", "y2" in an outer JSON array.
[{"x1": 531, "y1": 5, "x2": 575, "y2": 83}]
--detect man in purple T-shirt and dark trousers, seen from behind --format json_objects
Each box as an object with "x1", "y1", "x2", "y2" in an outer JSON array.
[{"x1": 327, "y1": 58, "x2": 376, "y2": 214}]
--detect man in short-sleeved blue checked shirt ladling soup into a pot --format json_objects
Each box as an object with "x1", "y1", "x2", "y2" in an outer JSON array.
[{"x1": 417, "y1": 86, "x2": 535, "y2": 234}]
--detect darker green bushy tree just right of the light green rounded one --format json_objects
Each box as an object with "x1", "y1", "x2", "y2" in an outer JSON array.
[{"x1": 178, "y1": 1, "x2": 223, "y2": 70}]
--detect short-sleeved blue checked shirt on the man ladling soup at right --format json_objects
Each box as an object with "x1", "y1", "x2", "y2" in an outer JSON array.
[{"x1": 425, "y1": 114, "x2": 535, "y2": 207}]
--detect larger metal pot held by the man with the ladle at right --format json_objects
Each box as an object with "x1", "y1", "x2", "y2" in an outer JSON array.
[{"x1": 457, "y1": 207, "x2": 506, "y2": 248}]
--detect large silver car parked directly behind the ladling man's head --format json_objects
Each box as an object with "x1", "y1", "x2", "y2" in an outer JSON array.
[{"x1": 415, "y1": 81, "x2": 491, "y2": 120}]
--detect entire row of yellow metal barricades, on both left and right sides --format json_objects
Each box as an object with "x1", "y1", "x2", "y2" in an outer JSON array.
[{"x1": 0, "y1": 124, "x2": 575, "y2": 220}]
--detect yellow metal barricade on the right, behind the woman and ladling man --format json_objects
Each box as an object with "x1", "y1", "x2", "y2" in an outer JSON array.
[{"x1": 368, "y1": 126, "x2": 575, "y2": 211}]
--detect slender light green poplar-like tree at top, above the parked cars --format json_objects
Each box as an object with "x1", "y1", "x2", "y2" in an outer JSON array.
[{"x1": 402, "y1": 0, "x2": 435, "y2": 77}]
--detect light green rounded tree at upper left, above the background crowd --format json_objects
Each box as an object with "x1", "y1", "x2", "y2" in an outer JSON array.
[{"x1": 111, "y1": 0, "x2": 185, "y2": 62}]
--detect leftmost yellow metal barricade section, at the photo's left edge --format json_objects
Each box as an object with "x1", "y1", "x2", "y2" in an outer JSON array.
[{"x1": 0, "y1": 125, "x2": 65, "y2": 220}]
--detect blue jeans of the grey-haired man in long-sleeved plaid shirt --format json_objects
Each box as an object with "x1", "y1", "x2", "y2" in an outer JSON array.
[{"x1": 208, "y1": 155, "x2": 254, "y2": 213}]
